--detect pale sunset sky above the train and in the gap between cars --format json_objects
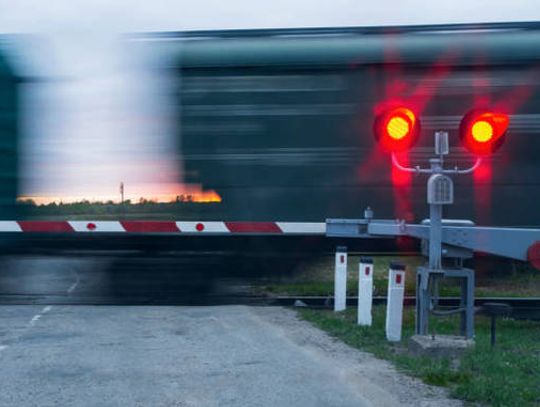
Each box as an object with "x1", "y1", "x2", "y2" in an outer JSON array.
[{"x1": 0, "y1": 0, "x2": 540, "y2": 202}]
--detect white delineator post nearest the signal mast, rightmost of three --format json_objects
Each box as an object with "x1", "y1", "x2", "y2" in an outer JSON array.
[{"x1": 386, "y1": 263, "x2": 405, "y2": 342}]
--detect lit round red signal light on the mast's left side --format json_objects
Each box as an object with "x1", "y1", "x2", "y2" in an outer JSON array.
[{"x1": 373, "y1": 106, "x2": 420, "y2": 152}]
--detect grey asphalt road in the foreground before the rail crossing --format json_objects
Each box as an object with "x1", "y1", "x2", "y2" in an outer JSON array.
[{"x1": 0, "y1": 305, "x2": 459, "y2": 407}]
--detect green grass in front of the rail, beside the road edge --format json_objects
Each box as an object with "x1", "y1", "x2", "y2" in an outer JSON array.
[{"x1": 299, "y1": 306, "x2": 540, "y2": 406}]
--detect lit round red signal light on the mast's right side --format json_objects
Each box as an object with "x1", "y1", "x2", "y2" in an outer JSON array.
[{"x1": 459, "y1": 110, "x2": 510, "y2": 155}]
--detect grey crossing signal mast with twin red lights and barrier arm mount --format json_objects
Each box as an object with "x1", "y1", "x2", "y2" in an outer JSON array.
[{"x1": 326, "y1": 105, "x2": 540, "y2": 338}]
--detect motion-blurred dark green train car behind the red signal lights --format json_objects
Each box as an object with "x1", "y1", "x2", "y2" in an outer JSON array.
[{"x1": 152, "y1": 23, "x2": 540, "y2": 226}]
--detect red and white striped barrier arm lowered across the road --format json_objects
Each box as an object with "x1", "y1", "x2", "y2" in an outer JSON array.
[{"x1": 0, "y1": 220, "x2": 326, "y2": 235}]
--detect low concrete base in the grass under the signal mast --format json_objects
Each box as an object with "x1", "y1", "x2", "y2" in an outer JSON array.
[{"x1": 409, "y1": 335, "x2": 474, "y2": 358}]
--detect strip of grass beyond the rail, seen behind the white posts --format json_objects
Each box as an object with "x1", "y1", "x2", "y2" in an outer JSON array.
[{"x1": 259, "y1": 256, "x2": 540, "y2": 297}]
